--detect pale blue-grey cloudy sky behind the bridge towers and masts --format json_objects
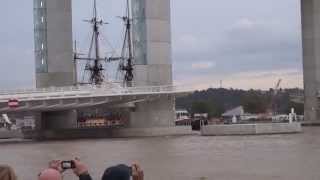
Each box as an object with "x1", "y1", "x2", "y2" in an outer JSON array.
[{"x1": 0, "y1": 0, "x2": 303, "y2": 89}]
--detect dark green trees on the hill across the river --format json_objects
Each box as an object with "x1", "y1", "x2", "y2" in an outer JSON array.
[{"x1": 176, "y1": 88, "x2": 304, "y2": 117}]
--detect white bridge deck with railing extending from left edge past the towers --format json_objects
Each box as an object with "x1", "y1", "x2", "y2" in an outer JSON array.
[{"x1": 0, "y1": 85, "x2": 193, "y2": 113}]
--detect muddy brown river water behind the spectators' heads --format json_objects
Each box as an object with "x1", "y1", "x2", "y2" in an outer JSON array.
[{"x1": 0, "y1": 127, "x2": 320, "y2": 180}]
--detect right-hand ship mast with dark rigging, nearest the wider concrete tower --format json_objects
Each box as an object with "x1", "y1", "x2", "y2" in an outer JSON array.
[{"x1": 108, "y1": 0, "x2": 134, "y2": 87}]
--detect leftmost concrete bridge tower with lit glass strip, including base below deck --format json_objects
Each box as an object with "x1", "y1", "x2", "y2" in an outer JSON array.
[{"x1": 34, "y1": 0, "x2": 77, "y2": 129}]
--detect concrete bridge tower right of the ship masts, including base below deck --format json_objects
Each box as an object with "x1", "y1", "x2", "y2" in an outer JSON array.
[{"x1": 130, "y1": 0, "x2": 175, "y2": 128}]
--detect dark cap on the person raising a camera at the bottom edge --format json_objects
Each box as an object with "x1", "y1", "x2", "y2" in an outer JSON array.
[{"x1": 102, "y1": 164, "x2": 132, "y2": 180}]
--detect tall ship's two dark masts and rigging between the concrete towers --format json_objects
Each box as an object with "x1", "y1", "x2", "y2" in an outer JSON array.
[{"x1": 74, "y1": 0, "x2": 134, "y2": 87}]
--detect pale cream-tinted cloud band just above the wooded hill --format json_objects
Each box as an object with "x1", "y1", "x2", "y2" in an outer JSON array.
[{"x1": 175, "y1": 69, "x2": 303, "y2": 90}]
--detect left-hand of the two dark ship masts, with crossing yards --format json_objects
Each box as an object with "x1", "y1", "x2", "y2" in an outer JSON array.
[{"x1": 74, "y1": 0, "x2": 107, "y2": 85}]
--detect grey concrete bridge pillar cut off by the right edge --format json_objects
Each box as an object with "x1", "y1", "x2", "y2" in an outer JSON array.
[{"x1": 301, "y1": 0, "x2": 320, "y2": 124}]
